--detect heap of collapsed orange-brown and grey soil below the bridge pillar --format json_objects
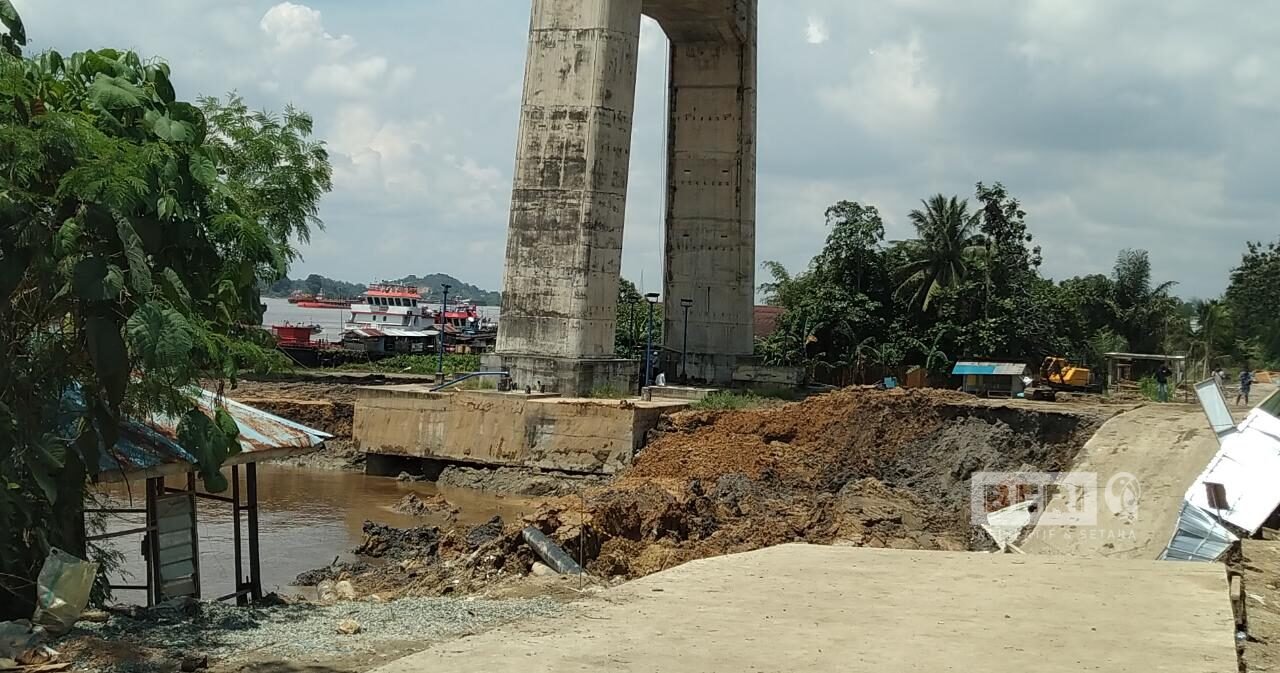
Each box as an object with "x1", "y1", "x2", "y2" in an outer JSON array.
[{"x1": 307, "y1": 389, "x2": 1101, "y2": 596}]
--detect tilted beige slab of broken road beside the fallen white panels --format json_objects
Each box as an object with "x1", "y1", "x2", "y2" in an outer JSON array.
[{"x1": 1020, "y1": 385, "x2": 1275, "y2": 559}]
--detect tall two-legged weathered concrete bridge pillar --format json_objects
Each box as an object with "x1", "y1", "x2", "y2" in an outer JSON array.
[{"x1": 498, "y1": 0, "x2": 755, "y2": 394}]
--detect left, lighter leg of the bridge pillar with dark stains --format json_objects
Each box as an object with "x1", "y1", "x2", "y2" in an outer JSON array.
[{"x1": 498, "y1": 0, "x2": 641, "y2": 394}]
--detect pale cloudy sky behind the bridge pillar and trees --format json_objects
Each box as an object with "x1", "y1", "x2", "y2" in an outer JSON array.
[{"x1": 14, "y1": 0, "x2": 1280, "y2": 296}]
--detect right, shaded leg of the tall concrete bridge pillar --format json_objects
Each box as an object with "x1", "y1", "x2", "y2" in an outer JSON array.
[{"x1": 644, "y1": 0, "x2": 756, "y2": 384}]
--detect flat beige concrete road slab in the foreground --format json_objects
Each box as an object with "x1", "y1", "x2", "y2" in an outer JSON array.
[{"x1": 379, "y1": 545, "x2": 1236, "y2": 673}]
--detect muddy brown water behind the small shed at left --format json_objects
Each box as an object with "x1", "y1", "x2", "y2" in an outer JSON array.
[{"x1": 93, "y1": 464, "x2": 538, "y2": 603}]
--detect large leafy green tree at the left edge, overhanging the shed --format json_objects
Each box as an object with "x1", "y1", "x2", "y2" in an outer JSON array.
[{"x1": 0, "y1": 15, "x2": 330, "y2": 618}]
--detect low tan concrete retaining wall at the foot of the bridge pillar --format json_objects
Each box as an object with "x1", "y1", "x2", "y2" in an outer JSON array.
[{"x1": 353, "y1": 385, "x2": 686, "y2": 473}]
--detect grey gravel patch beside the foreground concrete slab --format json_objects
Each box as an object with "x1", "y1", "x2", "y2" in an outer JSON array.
[{"x1": 70, "y1": 598, "x2": 564, "y2": 670}]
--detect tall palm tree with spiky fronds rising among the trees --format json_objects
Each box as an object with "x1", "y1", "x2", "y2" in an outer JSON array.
[{"x1": 897, "y1": 194, "x2": 986, "y2": 311}]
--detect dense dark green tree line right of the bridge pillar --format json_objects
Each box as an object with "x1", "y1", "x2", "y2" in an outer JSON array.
[{"x1": 756, "y1": 183, "x2": 1280, "y2": 383}]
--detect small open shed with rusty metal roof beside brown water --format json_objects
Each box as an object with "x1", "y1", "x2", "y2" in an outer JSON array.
[{"x1": 86, "y1": 390, "x2": 332, "y2": 605}]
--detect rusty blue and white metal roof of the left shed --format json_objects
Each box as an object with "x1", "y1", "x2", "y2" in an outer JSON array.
[{"x1": 85, "y1": 390, "x2": 333, "y2": 481}]
